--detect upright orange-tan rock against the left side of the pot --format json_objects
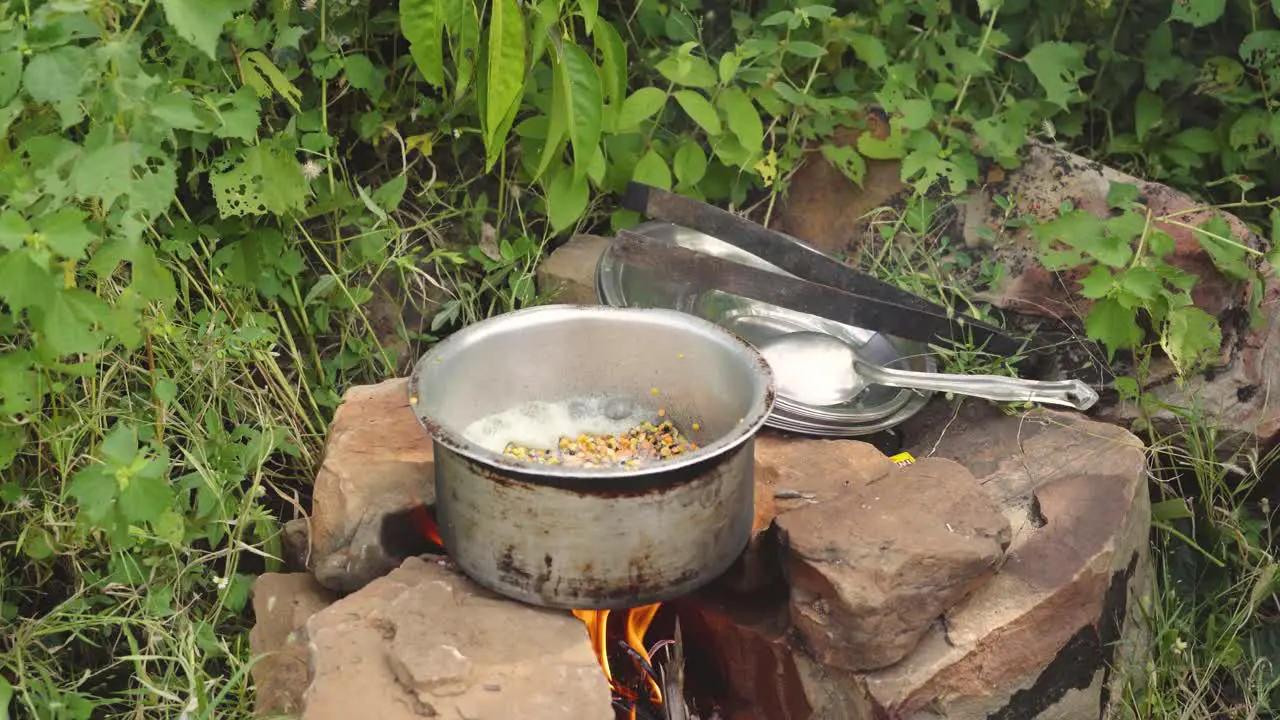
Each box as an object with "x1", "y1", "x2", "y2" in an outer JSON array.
[{"x1": 310, "y1": 378, "x2": 435, "y2": 592}]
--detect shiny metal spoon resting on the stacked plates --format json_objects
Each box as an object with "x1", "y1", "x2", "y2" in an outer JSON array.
[{"x1": 759, "y1": 332, "x2": 1098, "y2": 410}]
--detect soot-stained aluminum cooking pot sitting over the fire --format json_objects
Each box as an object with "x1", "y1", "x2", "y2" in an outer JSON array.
[{"x1": 410, "y1": 305, "x2": 773, "y2": 610}]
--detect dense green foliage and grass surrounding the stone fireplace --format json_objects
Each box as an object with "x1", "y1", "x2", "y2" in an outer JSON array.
[{"x1": 0, "y1": 0, "x2": 1280, "y2": 719}]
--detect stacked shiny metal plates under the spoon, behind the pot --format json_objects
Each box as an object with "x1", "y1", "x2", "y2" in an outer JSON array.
[{"x1": 595, "y1": 222, "x2": 937, "y2": 437}]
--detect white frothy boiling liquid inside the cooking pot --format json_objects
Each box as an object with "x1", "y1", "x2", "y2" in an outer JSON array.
[{"x1": 462, "y1": 395, "x2": 658, "y2": 452}]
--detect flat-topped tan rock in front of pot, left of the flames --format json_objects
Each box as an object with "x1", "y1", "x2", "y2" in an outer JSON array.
[{"x1": 302, "y1": 557, "x2": 612, "y2": 720}]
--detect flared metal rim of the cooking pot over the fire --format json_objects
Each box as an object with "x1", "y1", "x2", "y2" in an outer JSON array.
[{"x1": 408, "y1": 304, "x2": 774, "y2": 480}]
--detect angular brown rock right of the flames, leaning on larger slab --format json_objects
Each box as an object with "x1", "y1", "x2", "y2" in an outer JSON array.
[{"x1": 777, "y1": 460, "x2": 1010, "y2": 670}]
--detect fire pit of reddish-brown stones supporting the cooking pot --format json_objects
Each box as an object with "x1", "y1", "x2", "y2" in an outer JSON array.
[{"x1": 251, "y1": 368, "x2": 1149, "y2": 720}]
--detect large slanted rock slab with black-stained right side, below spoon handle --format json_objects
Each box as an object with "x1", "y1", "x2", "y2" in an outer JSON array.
[{"x1": 867, "y1": 404, "x2": 1151, "y2": 719}]
